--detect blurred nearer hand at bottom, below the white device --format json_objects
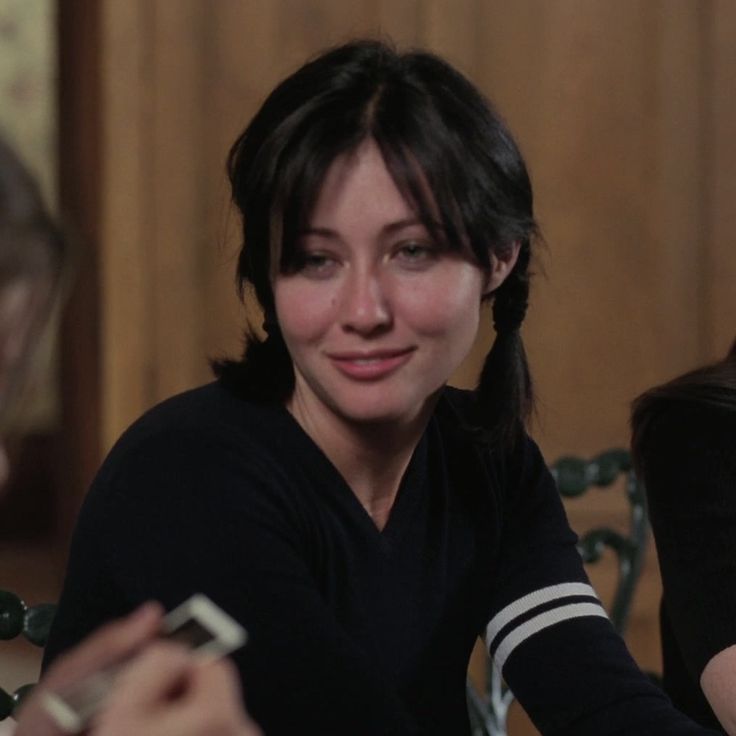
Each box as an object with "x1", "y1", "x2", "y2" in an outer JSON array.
[{"x1": 89, "y1": 642, "x2": 261, "y2": 736}]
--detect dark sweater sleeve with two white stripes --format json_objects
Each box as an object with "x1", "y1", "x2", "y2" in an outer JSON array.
[{"x1": 486, "y1": 441, "x2": 711, "y2": 736}]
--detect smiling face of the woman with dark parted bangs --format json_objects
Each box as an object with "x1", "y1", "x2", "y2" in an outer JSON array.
[{"x1": 273, "y1": 140, "x2": 513, "y2": 432}]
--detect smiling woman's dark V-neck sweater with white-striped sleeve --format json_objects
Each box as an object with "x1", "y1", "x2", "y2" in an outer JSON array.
[{"x1": 46, "y1": 383, "x2": 716, "y2": 736}]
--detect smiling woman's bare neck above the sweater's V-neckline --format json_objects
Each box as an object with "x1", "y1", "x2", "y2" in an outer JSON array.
[{"x1": 287, "y1": 397, "x2": 434, "y2": 529}]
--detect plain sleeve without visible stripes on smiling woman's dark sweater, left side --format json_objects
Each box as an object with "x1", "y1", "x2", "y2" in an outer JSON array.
[{"x1": 46, "y1": 420, "x2": 417, "y2": 736}]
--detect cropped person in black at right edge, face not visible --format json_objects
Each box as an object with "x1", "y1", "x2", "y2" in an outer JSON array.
[{"x1": 632, "y1": 343, "x2": 736, "y2": 734}]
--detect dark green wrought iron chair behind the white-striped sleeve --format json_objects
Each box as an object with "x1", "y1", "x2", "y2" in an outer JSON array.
[{"x1": 467, "y1": 449, "x2": 649, "y2": 736}]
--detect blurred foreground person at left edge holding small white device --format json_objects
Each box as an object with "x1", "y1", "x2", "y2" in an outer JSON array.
[{"x1": 0, "y1": 140, "x2": 259, "y2": 736}]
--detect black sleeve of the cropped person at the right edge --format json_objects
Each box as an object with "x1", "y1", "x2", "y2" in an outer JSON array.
[{"x1": 642, "y1": 404, "x2": 736, "y2": 683}]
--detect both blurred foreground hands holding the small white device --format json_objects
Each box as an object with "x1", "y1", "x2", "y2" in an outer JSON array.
[{"x1": 15, "y1": 604, "x2": 262, "y2": 736}]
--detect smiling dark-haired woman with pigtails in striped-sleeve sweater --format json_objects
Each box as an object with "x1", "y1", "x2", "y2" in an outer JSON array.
[{"x1": 47, "y1": 41, "x2": 707, "y2": 736}]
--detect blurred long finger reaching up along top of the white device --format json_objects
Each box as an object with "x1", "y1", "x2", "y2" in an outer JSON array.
[{"x1": 41, "y1": 602, "x2": 163, "y2": 689}]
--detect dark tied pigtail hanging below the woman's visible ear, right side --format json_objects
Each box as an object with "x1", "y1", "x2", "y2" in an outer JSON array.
[{"x1": 476, "y1": 239, "x2": 533, "y2": 447}]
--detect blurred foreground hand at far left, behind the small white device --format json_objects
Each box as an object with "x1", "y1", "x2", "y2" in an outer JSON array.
[{"x1": 15, "y1": 603, "x2": 163, "y2": 736}]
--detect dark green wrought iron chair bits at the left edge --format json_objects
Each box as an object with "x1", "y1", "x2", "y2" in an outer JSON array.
[{"x1": 0, "y1": 590, "x2": 56, "y2": 721}]
